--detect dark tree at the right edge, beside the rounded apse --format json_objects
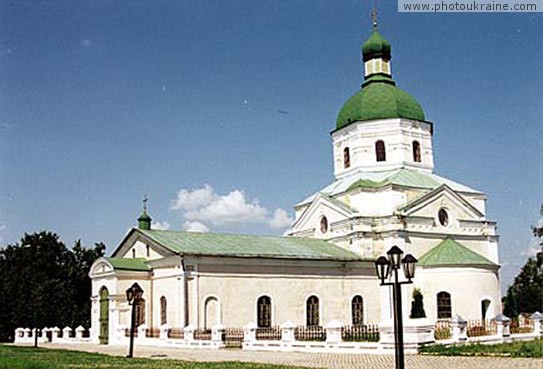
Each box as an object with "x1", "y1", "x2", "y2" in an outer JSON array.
[{"x1": 503, "y1": 205, "x2": 543, "y2": 317}]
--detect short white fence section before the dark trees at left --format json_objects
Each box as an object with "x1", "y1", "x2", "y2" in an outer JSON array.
[{"x1": 15, "y1": 326, "x2": 90, "y2": 344}]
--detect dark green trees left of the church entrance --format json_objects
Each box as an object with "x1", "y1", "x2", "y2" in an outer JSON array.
[{"x1": 0, "y1": 231, "x2": 105, "y2": 341}]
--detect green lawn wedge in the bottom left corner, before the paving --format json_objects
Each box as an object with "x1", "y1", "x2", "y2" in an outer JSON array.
[{"x1": 0, "y1": 345, "x2": 310, "y2": 369}]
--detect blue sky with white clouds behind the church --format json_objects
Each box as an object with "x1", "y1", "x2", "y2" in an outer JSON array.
[{"x1": 0, "y1": 0, "x2": 543, "y2": 290}]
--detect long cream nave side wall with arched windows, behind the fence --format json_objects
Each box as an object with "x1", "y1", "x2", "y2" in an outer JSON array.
[{"x1": 189, "y1": 263, "x2": 380, "y2": 327}]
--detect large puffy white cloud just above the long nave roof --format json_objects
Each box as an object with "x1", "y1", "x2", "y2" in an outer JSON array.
[{"x1": 170, "y1": 184, "x2": 293, "y2": 231}]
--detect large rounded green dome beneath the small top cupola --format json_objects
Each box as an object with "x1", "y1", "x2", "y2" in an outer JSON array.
[{"x1": 336, "y1": 75, "x2": 425, "y2": 129}]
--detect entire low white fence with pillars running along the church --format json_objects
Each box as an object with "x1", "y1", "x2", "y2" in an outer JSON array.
[{"x1": 15, "y1": 313, "x2": 543, "y2": 353}]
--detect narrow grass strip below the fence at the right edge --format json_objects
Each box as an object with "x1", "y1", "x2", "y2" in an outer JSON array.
[{"x1": 420, "y1": 339, "x2": 543, "y2": 358}]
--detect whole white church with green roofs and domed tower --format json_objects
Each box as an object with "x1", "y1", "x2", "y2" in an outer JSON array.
[{"x1": 90, "y1": 18, "x2": 501, "y2": 344}]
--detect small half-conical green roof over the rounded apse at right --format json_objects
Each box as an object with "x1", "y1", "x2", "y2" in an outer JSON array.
[{"x1": 417, "y1": 238, "x2": 496, "y2": 266}]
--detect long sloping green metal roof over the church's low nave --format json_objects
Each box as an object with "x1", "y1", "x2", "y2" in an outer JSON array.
[{"x1": 137, "y1": 229, "x2": 363, "y2": 260}]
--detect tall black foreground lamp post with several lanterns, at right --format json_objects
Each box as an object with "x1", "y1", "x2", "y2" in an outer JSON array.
[{"x1": 375, "y1": 246, "x2": 417, "y2": 369}]
